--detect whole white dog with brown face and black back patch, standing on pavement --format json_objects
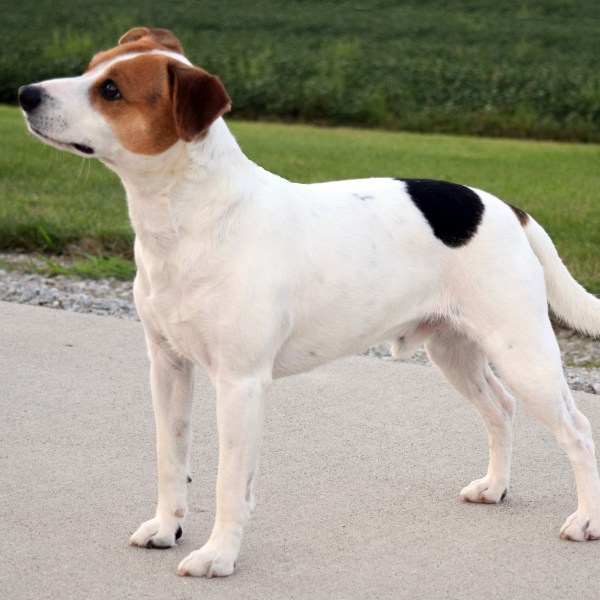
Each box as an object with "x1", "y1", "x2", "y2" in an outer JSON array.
[{"x1": 19, "y1": 28, "x2": 600, "y2": 577}]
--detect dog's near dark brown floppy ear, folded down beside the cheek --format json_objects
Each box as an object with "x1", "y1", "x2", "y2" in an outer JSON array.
[{"x1": 169, "y1": 62, "x2": 231, "y2": 142}]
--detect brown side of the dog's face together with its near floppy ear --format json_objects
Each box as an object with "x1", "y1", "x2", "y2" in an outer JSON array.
[{"x1": 90, "y1": 53, "x2": 231, "y2": 155}]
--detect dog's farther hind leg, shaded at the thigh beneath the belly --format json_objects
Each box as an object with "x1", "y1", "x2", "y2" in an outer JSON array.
[{"x1": 425, "y1": 326, "x2": 515, "y2": 504}]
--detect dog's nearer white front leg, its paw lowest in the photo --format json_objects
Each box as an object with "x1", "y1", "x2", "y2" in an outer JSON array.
[{"x1": 177, "y1": 376, "x2": 270, "y2": 577}]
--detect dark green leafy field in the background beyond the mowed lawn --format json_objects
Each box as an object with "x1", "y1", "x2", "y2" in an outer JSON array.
[{"x1": 0, "y1": 0, "x2": 600, "y2": 142}]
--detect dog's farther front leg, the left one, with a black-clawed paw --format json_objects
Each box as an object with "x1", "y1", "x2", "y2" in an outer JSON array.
[{"x1": 129, "y1": 336, "x2": 194, "y2": 548}]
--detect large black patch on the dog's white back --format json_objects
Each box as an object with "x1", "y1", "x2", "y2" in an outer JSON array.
[{"x1": 398, "y1": 179, "x2": 484, "y2": 248}]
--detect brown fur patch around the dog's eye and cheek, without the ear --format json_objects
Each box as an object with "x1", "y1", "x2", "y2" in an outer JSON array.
[{"x1": 90, "y1": 54, "x2": 179, "y2": 155}]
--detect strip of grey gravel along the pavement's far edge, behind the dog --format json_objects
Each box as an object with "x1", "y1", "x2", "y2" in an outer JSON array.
[{"x1": 0, "y1": 254, "x2": 600, "y2": 394}]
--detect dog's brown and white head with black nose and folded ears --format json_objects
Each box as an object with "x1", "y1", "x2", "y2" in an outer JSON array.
[{"x1": 19, "y1": 27, "x2": 231, "y2": 164}]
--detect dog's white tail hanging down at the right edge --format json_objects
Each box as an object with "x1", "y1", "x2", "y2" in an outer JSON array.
[{"x1": 517, "y1": 211, "x2": 600, "y2": 337}]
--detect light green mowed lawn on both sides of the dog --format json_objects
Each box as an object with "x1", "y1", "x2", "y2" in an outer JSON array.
[{"x1": 0, "y1": 106, "x2": 600, "y2": 294}]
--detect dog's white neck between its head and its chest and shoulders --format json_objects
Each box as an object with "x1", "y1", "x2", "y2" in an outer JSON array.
[{"x1": 113, "y1": 118, "x2": 263, "y2": 256}]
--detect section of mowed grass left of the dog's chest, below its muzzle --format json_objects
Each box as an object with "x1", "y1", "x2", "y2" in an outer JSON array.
[{"x1": 0, "y1": 107, "x2": 133, "y2": 256}]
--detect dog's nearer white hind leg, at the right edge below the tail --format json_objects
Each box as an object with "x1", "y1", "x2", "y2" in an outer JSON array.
[{"x1": 464, "y1": 276, "x2": 600, "y2": 541}]
